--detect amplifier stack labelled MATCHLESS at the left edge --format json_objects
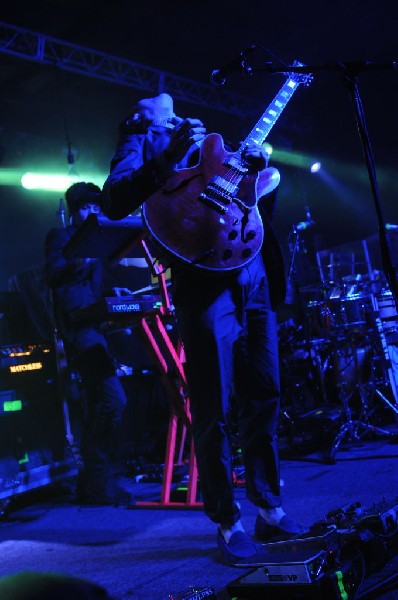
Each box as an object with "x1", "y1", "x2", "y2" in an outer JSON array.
[{"x1": 0, "y1": 343, "x2": 77, "y2": 501}]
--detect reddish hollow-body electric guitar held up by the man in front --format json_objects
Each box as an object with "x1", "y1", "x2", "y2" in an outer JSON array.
[{"x1": 142, "y1": 62, "x2": 311, "y2": 273}]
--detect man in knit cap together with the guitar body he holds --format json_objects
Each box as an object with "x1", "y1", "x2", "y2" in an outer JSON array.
[{"x1": 103, "y1": 94, "x2": 303, "y2": 566}]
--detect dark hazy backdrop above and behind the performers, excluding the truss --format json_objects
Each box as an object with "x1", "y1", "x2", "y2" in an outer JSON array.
[{"x1": 0, "y1": 0, "x2": 398, "y2": 290}]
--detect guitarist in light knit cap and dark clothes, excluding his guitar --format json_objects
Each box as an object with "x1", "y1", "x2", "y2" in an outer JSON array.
[{"x1": 103, "y1": 93, "x2": 302, "y2": 565}]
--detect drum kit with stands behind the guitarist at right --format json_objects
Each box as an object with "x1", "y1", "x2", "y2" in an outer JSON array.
[{"x1": 279, "y1": 251, "x2": 398, "y2": 463}]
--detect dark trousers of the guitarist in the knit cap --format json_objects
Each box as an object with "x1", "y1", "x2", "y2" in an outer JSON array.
[{"x1": 173, "y1": 255, "x2": 281, "y2": 525}]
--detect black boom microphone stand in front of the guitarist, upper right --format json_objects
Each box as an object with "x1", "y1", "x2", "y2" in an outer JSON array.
[{"x1": 251, "y1": 61, "x2": 398, "y2": 310}]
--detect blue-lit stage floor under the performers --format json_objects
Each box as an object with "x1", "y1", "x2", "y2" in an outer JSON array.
[{"x1": 0, "y1": 439, "x2": 398, "y2": 600}]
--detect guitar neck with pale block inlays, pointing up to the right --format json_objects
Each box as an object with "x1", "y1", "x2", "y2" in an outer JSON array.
[{"x1": 239, "y1": 62, "x2": 301, "y2": 151}]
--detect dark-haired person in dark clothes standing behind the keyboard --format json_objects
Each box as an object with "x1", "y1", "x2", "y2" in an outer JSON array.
[{"x1": 45, "y1": 182, "x2": 129, "y2": 504}]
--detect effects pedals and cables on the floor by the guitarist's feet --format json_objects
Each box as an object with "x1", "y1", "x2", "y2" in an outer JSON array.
[{"x1": 227, "y1": 498, "x2": 398, "y2": 600}]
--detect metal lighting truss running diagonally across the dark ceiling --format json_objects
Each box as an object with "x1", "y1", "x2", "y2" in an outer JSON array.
[{"x1": 0, "y1": 22, "x2": 262, "y2": 118}]
